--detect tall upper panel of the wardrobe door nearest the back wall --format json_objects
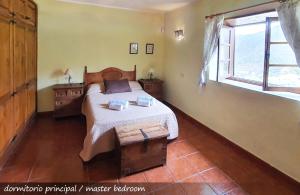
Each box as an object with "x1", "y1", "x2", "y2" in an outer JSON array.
[{"x1": 26, "y1": 28, "x2": 36, "y2": 82}]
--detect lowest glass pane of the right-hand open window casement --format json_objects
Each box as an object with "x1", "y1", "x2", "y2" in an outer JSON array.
[{"x1": 268, "y1": 67, "x2": 300, "y2": 87}]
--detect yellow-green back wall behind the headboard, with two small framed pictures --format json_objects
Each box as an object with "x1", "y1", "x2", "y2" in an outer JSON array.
[{"x1": 37, "y1": 0, "x2": 164, "y2": 112}]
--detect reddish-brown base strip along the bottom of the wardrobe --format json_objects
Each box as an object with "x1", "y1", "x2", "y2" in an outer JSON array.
[{"x1": 0, "y1": 113, "x2": 36, "y2": 171}]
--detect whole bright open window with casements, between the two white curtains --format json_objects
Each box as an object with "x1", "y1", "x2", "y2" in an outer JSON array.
[{"x1": 210, "y1": 11, "x2": 300, "y2": 93}]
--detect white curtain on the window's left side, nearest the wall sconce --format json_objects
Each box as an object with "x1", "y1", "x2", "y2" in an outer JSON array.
[{"x1": 199, "y1": 15, "x2": 224, "y2": 86}]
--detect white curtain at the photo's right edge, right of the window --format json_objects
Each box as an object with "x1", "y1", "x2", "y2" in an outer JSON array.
[{"x1": 277, "y1": 0, "x2": 300, "y2": 66}]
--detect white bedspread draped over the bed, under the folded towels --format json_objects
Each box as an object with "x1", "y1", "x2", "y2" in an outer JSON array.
[{"x1": 80, "y1": 85, "x2": 178, "y2": 161}]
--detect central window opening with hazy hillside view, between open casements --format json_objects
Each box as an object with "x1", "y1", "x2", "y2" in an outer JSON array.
[{"x1": 234, "y1": 24, "x2": 266, "y2": 82}]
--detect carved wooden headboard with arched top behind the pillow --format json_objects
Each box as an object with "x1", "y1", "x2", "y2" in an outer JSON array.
[{"x1": 83, "y1": 65, "x2": 136, "y2": 86}]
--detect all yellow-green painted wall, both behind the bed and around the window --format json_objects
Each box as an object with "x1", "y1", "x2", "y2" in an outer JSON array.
[{"x1": 37, "y1": 0, "x2": 300, "y2": 181}]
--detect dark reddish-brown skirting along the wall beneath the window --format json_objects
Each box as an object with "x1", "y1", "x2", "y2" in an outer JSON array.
[{"x1": 164, "y1": 101, "x2": 300, "y2": 188}]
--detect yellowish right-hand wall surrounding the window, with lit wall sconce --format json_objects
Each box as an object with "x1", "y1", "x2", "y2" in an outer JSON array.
[{"x1": 164, "y1": 0, "x2": 300, "y2": 181}]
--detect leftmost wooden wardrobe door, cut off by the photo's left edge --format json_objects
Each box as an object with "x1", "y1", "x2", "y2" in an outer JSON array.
[{"x1": 0, "y1": 0, "x2": 14, "y2": 155}]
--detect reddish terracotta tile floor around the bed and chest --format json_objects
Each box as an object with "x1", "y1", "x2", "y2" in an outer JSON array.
[{"x1": 0, "y1": 113, "x2": 300, "y2": 195}]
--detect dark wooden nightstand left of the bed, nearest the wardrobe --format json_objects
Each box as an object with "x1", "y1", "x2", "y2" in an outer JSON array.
[{"x1": 53, "y1": 83, "x2": 84, "y2": 118}]
